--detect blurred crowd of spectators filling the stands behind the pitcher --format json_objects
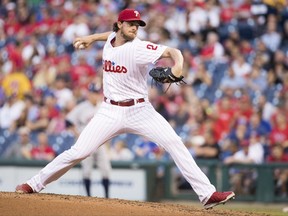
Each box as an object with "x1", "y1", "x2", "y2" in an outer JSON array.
[{"x1": 0, "y1": 0, "x2": 288, "y2": 194}]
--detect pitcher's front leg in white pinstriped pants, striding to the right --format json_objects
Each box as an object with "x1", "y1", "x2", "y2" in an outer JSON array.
[{"x1": 129, "y1": 106, "x2": 216, "y2": 203}]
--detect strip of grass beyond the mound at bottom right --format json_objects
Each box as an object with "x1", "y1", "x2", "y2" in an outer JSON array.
[{"x1": 164, "y1": 200, "x2": 288, "y2": 216}]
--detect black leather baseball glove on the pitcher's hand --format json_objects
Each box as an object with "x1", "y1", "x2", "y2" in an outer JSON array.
[{"x1": 149, "y1": 67, "x2": 186, "y2": 92}]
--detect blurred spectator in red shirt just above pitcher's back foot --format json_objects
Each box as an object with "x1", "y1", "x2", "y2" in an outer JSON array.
[{"x1": 31, "y1": 132, "x2": 56, "y2": 161}]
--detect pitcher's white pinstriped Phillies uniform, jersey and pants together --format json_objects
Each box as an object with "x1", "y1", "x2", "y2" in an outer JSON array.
[{"x1": 27, "y1": 32, "x2": 216, "y2": 203}]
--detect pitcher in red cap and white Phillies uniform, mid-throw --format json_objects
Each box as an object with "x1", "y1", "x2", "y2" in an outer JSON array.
[{"x1": 16, "y1": 9, "x2": 235, "y2": 209}]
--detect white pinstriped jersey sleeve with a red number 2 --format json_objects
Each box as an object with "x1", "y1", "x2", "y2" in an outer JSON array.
[{"x1": 135, "y1": 39, "x2": 167, "y2": 65}]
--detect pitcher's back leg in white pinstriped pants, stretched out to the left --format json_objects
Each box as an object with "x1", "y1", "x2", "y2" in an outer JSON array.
[{"x1": 27, "y1": 105, "x2": 122, "y2": 192}]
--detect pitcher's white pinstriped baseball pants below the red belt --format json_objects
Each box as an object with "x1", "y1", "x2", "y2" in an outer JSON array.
[{"x1": 27, "y1": 102, "x2": 216, "y2": 203}]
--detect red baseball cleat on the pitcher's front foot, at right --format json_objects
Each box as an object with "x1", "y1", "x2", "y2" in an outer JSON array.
[{"x1": 204, "y1": 191, "x2": 235, "y2": 209}]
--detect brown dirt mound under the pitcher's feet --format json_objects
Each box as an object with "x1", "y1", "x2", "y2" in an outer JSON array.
[{"x1": 0, "y1": 192, "x2": 263, "y2": 216}]
